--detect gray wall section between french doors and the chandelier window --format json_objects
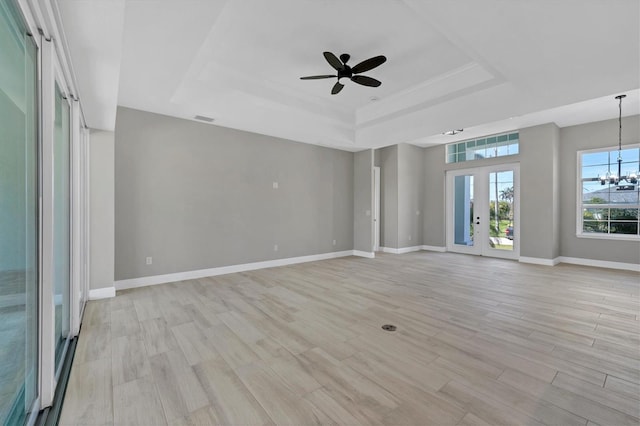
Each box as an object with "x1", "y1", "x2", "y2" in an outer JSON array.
[{"x1": 519, "y1": 123, "x2": 560, "y2": 259}]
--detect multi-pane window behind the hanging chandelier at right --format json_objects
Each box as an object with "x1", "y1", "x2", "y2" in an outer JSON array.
[{"x1": 577, "y1": 145, "x2": 640, "y2": 239}]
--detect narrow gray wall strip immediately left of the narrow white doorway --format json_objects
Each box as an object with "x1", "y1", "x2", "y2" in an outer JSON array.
[{"x1": 353, "y1": 149, "x2": 373, "y2": 253}]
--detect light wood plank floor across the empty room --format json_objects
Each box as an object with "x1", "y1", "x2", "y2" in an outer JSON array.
[{"x1": 61, "y1": 252, "x2": 640, "y2": 425}]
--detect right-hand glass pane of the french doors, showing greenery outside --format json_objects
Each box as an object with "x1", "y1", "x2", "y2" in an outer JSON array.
[{"x1": 488, "y1": 170, "x2": 517, "y2": 251}]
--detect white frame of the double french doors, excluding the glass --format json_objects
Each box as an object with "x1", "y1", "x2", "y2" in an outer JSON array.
[{"x1": 445, "y1": 163, "x2": 521, "y2": 259}]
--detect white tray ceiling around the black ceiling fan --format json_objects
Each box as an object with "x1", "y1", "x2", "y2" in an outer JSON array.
[{"x1": 58, "y1": 0, "x2": 640, "y2": 151}]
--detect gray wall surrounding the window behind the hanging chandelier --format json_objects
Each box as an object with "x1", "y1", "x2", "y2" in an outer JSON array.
[{"x1": 560, "y1": 115, "x2": 640, "y2": 264}]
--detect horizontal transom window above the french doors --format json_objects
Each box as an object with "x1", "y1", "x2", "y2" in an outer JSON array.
[{"x1": 447, "y1": 132, "x2": 520, "y2": 163}]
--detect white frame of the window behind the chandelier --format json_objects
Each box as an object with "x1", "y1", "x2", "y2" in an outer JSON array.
[{"x1": 576, "y1": 143, "x2": 640, "y2": 241}]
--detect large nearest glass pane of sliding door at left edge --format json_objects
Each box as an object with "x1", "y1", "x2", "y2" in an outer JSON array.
[{"x1": 0, "y1": 2, "x2": 38, "y2": 424}]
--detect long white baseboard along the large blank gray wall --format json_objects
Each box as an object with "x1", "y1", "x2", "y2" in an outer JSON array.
[{"x1": 115, "y1": 250, "x2": 355, "y2": 290}]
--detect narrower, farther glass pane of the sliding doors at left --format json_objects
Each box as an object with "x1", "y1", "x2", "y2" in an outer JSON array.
[{"x1": 53, "y1": 84, "x2": 70, "y2": 366}]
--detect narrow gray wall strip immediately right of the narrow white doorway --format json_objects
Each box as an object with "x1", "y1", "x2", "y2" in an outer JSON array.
[{"x1": 379, "y1": 145, "x2": 398, "y2": 248}]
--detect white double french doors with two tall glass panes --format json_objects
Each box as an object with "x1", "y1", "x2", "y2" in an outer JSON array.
[{"x1": 446, "y1": 164, "x2": 520, "y2": 259}]
